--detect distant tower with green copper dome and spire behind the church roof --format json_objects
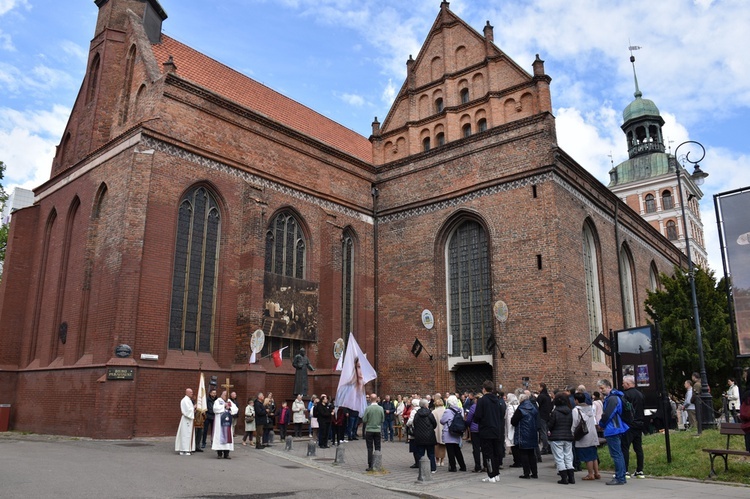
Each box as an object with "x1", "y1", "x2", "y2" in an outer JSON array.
[{"x1": 609, "y1": 55, "x2": 708, "y2": 267}]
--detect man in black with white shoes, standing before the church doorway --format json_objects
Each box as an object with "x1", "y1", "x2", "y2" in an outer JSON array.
[{"x1": 474, "y1": 380, "x2": 505, "y2": 483}]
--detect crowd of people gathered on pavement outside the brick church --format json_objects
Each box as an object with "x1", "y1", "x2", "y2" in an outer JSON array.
[{"x1": 175, "y1": 376, "x2": 676, "y2": 485}]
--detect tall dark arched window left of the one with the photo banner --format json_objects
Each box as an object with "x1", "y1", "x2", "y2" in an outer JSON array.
[{"x1": 169, "y1": 186, "x2": 221, "y2": 352}]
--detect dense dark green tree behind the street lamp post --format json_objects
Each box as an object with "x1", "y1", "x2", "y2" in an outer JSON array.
[{"x1": 645, "y1": 267, "x2": 735, "y2": 407}]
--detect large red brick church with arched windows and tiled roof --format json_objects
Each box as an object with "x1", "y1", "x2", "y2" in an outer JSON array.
[{"x1": 0, "y1": 0, "x2": 681, "y2": 438}]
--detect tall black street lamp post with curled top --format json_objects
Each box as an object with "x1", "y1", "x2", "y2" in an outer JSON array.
[{"x1": 674, "y1": 140, "x2": 713, "y2": 434}]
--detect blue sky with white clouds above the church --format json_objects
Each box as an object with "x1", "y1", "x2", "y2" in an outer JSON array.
[{"x1": 0, "y1": 0, "x2": 750, "y2": 276}]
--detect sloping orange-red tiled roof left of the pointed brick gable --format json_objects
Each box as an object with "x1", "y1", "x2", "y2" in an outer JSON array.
[{"x1": 152, "y1": 34, "x2": 372, "y2": 163}]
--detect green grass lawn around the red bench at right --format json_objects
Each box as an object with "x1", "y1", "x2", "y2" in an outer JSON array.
[{"x1": 599, "y1": 429, "x2": 750, "y2": 485}]
